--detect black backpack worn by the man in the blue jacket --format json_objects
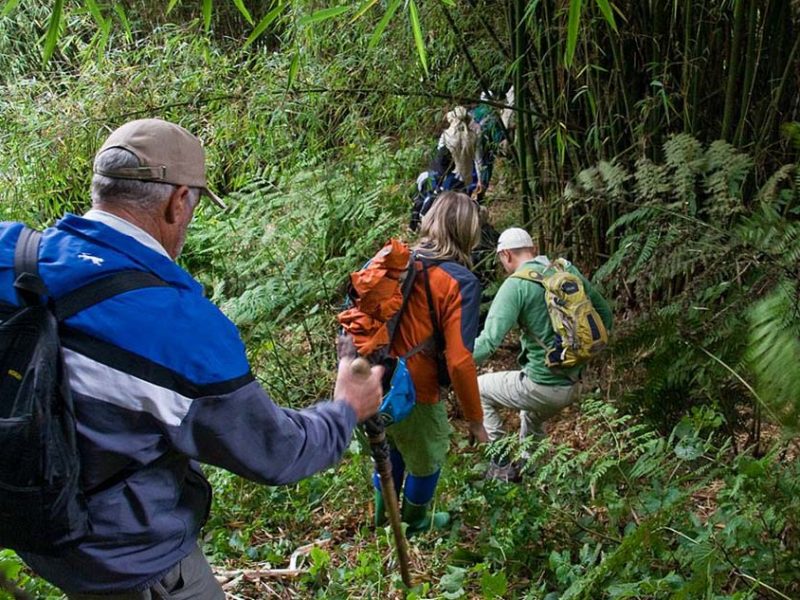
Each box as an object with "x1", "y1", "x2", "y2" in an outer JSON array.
[{"x1": 0, "y1": 227, "x2": 168, "y2": 554}]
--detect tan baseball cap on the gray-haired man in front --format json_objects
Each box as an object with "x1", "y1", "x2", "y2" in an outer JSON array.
[{"x1": 94, "y1": 119, "x2": 225, "y2": 208}]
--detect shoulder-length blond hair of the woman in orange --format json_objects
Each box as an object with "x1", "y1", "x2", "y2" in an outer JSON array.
[{"x1": 415, "y1": 192, "x2": 481, "y2": 268}]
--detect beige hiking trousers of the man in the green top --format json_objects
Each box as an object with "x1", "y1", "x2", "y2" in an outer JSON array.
[{"x1": 478, "y1": 371, "x2": 578, "y2": 442}]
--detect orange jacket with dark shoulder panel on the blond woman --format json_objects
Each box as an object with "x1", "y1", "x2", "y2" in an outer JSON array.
[{"x1": 392, "y1": 261, "x2": 483, "y2": 421}]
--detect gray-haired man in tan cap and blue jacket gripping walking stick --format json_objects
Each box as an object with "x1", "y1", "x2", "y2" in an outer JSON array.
[{"x1": 0, "y1": 119, "x2": 382, "y2": 600}]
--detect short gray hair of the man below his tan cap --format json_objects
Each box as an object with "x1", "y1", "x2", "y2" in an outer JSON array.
[{"x1": 92, "y1": 148, "x2": 200, "y2": 212}]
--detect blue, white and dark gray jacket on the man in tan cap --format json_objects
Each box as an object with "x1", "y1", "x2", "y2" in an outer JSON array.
[{"x1": 0, "y1": 215, "x2": 356, "y2": 593}]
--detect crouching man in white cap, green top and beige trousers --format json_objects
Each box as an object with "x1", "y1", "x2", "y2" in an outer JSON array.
[{"x1": 474, "y1": 227, "x2": 612, "y2": 481}]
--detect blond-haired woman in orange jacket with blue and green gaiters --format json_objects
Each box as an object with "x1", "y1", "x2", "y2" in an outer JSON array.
[{"x1": 374, "y1": 192, "x2": 487, "y2": 533}]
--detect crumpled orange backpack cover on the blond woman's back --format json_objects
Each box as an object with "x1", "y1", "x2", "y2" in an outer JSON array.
[{"x1": 337, "y1": 239, "x2": 413, "y2": 356}]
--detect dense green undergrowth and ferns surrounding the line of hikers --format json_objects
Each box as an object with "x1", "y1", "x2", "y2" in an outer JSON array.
[{"x1": 0, "y1": 3, "x2": 800, "y2": 600}]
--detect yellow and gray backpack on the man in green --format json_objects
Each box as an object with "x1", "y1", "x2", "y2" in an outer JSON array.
[{"x1": 512, "y1": 258, "x2": 608, "y2": 369}]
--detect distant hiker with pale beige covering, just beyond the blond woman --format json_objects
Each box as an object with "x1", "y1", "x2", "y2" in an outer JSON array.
[{"x1": 430, "y1": 106, "x2": 483, "y2": 192}]
